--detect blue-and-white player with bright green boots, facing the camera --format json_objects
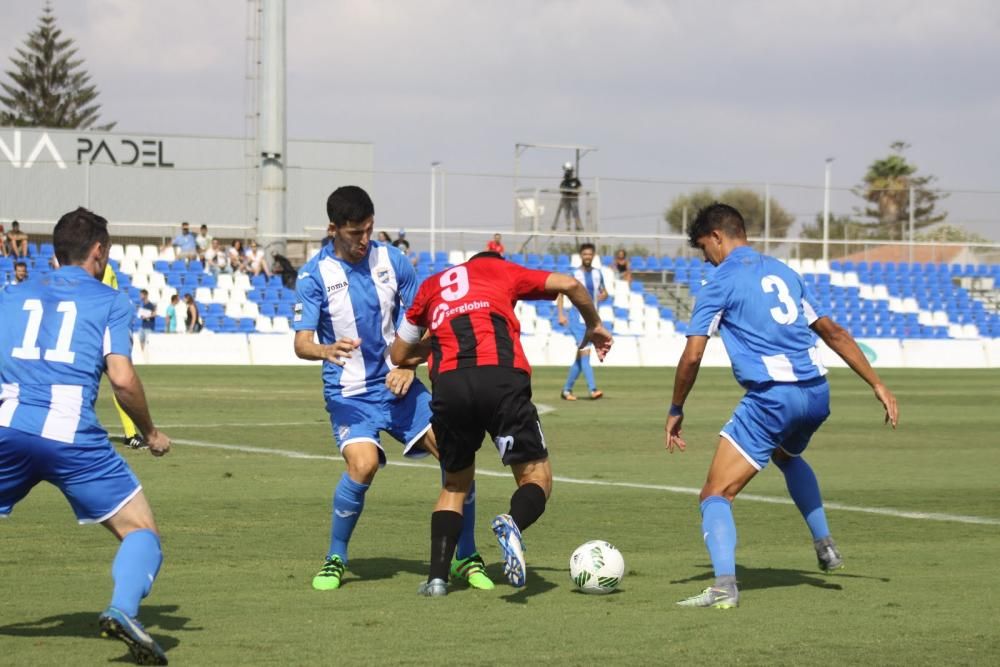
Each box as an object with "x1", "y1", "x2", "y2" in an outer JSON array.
[{"x1": 292, "y1": 186, "x2": 493, "y2": 590}]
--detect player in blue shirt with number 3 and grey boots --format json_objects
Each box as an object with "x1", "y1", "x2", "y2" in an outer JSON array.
[{"x1": 665, "y1": 204, "x2": 899, "y2": 609}]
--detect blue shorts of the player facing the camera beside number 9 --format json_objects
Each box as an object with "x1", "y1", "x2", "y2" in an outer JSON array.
[{"x1": 326, "y1": 380, "x2": 431, "y2": 466}]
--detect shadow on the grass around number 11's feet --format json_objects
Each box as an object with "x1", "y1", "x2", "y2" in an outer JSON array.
[{"x1": 0, "y1": 605, "x2": 202, "y2": 663}]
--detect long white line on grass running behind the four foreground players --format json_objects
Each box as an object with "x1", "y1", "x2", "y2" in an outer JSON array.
[{"x1": 173, "y1": 439, "x2": 1000, "y2": 526}]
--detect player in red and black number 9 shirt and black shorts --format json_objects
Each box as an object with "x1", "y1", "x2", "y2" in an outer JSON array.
[{"x1": 392, "y1": 252, "x2": 612, "y2": 597}]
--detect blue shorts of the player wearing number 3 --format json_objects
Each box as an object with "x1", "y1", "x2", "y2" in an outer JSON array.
[{"x1": 719, "y1": 378, "x2": 830, "y2": 470}]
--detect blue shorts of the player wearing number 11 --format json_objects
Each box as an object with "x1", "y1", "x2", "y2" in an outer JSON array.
[{"x1": 0, "y1": 427, "x2": 142, "y2": 523}]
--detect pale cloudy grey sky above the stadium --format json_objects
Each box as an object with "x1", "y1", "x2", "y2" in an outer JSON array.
[{"x1": 0, "y1": 0, "x2": 1000, "y2": 240}]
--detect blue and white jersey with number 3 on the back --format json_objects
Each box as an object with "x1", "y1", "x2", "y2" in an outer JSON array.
[{"x1": 687, "y1": 246, "x2": 828, "y2": 388}]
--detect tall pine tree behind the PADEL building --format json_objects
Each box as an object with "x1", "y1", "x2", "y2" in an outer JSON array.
[{"x1": 0, "y1": 2, "x2": 115, "y2": 130}]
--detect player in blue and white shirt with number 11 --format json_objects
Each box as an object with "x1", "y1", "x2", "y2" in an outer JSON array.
[{"x1": 0, "y1": 208, "x2": 170, "y2": 665}]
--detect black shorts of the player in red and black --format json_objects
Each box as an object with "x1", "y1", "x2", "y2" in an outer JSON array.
[{"x1": 431, "y1": 366, "x2": 549, "y2": 472}]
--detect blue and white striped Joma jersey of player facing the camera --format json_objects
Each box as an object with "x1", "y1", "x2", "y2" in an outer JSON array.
[{"x1": 292, "y1": 241, "x2": 417, "y2": 398}]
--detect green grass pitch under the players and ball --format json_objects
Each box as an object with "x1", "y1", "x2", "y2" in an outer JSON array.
[{"x1": 0, "y1": 367, "x2": 1000, "y2": 665}]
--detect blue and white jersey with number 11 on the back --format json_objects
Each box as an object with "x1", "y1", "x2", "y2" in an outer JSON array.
[{"x1": 0, "y1": 266, "x2": 135, "y2": 447}]
